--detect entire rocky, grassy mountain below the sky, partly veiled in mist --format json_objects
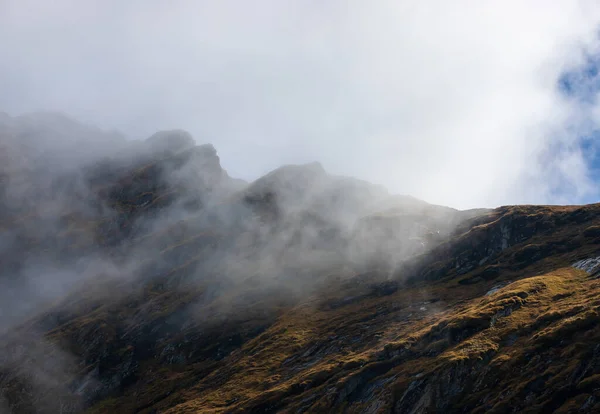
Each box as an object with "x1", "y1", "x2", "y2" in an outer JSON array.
[{"x1": 0, "y1": 114, "x2": 600, "y2": 413}]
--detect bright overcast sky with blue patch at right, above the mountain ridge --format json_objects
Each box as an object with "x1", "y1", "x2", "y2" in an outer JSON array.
[{"x1": 0, "y1": 0, "x2": 600, "y2": 208}]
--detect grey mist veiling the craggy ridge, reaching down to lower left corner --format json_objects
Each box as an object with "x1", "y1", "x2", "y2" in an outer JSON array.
[{"x1": 0, "y1": 113, "x2": 484, "y2": 412}]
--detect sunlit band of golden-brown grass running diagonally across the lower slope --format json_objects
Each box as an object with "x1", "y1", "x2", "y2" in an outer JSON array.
[{"x1": 71, "y1": 268, "x2": 600, "y2": 414}]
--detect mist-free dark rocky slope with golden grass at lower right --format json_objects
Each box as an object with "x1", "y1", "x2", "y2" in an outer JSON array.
[{"x1": 82, "y1": 206, "x2": 600, "y2": 413}]
